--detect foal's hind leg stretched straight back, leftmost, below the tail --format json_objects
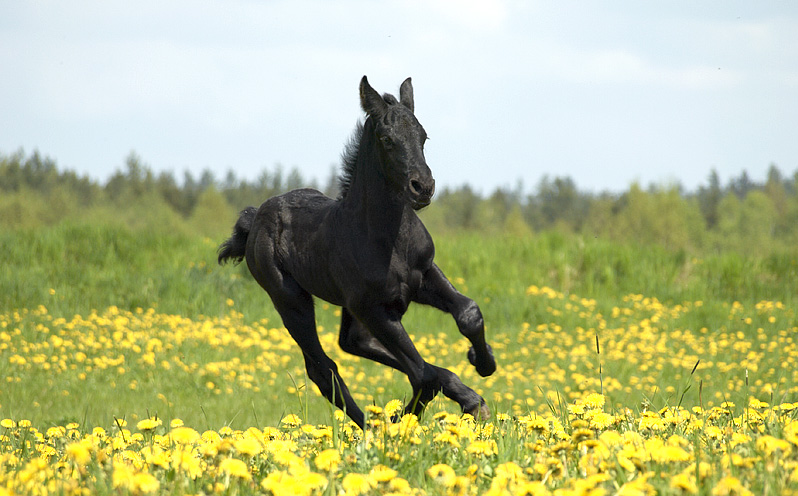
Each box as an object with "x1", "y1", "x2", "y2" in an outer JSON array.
[{"x1": 269, "y1": 277, "x2": 364, "y2": 429}]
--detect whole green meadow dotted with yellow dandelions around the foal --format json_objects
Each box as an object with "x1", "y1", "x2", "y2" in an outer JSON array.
[{"x1": 0, "y1": 224, "x2": 798, "y2": 495}]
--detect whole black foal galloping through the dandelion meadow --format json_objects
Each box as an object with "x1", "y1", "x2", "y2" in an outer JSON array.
[{"x1": 219, "y1": 76, "x2": 496, "y2": 428}]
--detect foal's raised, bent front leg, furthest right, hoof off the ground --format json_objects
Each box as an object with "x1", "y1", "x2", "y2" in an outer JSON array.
[{"x1": 414, "y1": 264, "x2": 496, "y2": 377}]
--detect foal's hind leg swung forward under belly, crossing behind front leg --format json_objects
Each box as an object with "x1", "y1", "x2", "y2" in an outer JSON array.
[{"x1": 339, "y1": 308, "x2": 490, "y2": 418}]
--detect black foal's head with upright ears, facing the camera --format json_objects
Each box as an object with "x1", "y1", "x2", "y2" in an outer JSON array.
[{"x1": 360, "y1": 76, "x2": 435, "y2": 210}]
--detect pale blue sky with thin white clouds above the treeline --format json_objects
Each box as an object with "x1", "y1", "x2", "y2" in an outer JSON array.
[{"x1": 0, "y1": 0, "x2": 798, "y2": 194}]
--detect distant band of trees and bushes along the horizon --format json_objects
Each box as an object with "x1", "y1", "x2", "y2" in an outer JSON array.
[{"x1": 0, "y1": 151, "x2": 798, "y2": 254}]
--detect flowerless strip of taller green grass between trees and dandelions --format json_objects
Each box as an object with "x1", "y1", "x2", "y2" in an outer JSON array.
[{"x1": 0, "y1": 223, "x2": 798, "y2": 330}]
